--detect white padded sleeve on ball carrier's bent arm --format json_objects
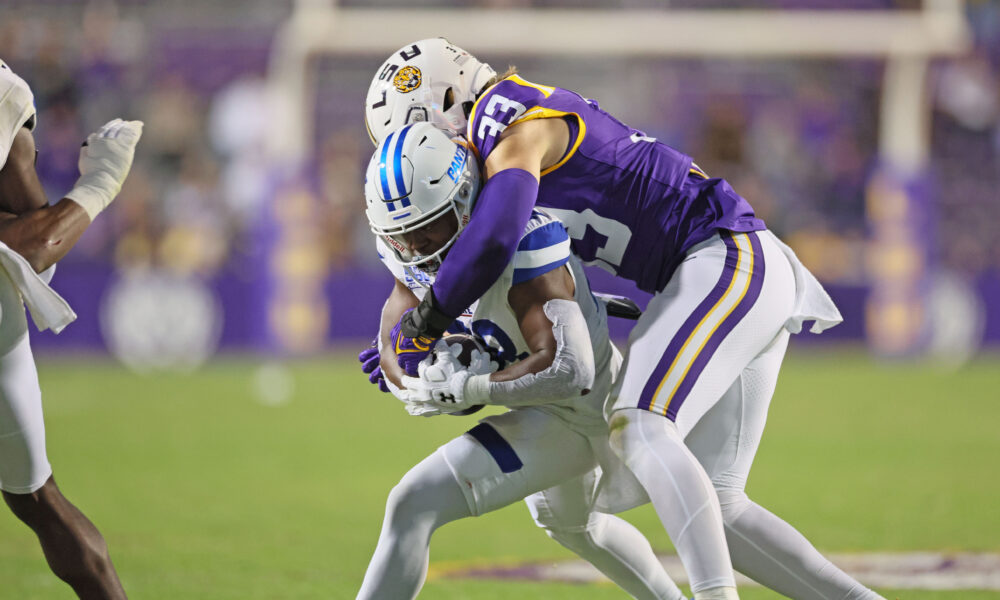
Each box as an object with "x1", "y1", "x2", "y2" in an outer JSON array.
[{"x1": 464, "y1": 300, "x2": 595, "y2": 406}]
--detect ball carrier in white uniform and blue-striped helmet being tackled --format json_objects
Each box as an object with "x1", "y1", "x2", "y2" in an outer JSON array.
[{"x1": 358, "y1": 124, "x2": 683, "y2": 600}]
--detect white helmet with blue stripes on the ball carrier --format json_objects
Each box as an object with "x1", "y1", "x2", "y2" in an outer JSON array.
[{"x1": 365, "y1": 123, "x2": 480, "y2": 273}]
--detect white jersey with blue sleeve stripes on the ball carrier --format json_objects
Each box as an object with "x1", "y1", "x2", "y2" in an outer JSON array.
[{"x1": 378, "y1": 209, "x2": 617, "y2": 434}]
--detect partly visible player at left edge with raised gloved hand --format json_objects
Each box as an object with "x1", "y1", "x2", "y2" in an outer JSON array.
[{"x1": 0, "y1": 61, "x2": 142, "y2": 599}]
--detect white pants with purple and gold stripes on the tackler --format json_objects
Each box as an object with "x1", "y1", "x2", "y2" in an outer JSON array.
[{"x1": 609, "y1": 231, "x2": 878, "y2": 600}]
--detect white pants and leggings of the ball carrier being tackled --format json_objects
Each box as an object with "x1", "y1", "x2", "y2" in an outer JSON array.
[{"x1": 358, "y1": 408, "x2": 684, "y2": 600}]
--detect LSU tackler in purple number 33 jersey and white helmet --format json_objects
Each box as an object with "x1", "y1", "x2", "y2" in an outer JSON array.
[{"x1": 365, "y1": 40, "x2": 878, "y2": 600}]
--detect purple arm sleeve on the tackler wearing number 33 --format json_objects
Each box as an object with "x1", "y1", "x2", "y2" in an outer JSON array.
[{"x1": 433, "y1": 169, "x2": 538, "y2": 318}]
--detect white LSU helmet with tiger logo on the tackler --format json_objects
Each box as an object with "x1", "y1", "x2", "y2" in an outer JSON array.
[{"x1": 365, "y1": 38, "x2": 496, "y2": 144}]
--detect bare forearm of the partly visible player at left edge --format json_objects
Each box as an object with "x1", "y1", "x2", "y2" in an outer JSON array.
[{"x1": 0, "y1": 198, "x2": 90, "y2": 273}]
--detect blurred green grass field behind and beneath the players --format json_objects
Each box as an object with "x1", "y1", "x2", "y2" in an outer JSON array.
[{"x1": 0, "y1": 352, "x2": 1000, "y2": 600}]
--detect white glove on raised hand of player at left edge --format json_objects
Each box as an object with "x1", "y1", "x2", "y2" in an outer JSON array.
[{"x1": 66, "y1": 119, "x2": 142, "y2": 221}]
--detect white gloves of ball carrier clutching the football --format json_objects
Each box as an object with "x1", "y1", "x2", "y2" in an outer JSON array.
[{"x1": 403, "y1": 340, "x2": 499, "y2": 414}]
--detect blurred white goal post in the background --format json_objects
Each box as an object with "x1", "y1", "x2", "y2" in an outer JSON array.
[{"x1": 268, "y1": 0, "x2": 972, "y2": 355}]
